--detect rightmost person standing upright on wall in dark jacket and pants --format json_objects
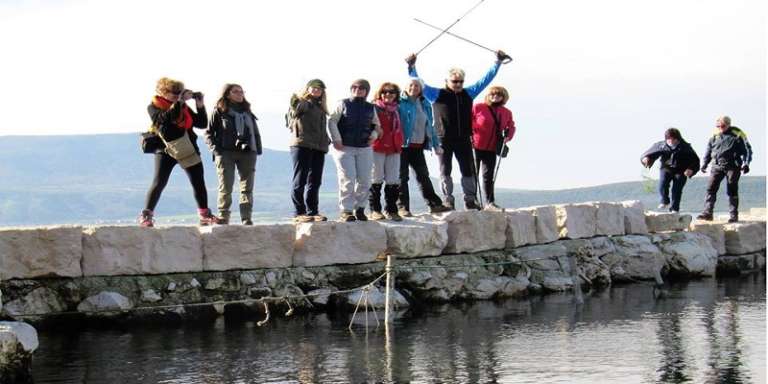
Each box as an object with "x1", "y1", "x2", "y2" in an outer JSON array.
[{"x1": 696, "y1": 116, "x2": 750, "y2": 223}]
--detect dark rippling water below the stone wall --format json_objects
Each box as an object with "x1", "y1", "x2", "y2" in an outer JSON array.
[{"x1": 33, "y1": 274, "x2": 766, "y2": 384}]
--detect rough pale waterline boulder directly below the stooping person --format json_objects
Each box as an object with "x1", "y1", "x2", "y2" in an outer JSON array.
[{"x1": 659, "y1": 232, "x2": 718, "y2": 276}]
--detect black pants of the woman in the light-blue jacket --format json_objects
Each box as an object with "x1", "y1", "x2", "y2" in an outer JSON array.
[{"x1": 397, "y1": 148, "x2": 443, "y2": 211}]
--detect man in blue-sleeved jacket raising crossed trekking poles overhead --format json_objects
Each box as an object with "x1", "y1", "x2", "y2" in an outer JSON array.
[{"x1": 405, "y1": 51, "x2": 507, "y2": 210}]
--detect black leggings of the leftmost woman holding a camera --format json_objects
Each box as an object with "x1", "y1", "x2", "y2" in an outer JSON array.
[{"x1": 144, "y1": 153, "x2": 208, "y2": 211}]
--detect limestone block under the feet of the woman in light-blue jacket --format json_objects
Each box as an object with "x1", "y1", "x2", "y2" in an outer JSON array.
[{"x1": 382, "y1": 220, "x2": 448, "y2": 258}]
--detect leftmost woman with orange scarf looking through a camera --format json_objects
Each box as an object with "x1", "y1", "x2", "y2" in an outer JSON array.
[{"x1": 139, "y1": 77, "x2": 219, "y2": 227}]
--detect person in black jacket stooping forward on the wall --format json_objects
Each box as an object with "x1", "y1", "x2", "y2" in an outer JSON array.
[{"x1": 640, "y1": 128, "x2": 699, "y2": 212}]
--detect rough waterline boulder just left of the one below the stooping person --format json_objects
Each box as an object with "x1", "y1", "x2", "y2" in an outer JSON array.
[{"x1": 601, "y1": 235, "x2": 666, "y2": 281}]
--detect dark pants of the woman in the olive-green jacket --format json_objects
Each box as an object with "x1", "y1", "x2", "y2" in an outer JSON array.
[{"x1": 291, "y1": 146, "x2": 325, "y2": 216}]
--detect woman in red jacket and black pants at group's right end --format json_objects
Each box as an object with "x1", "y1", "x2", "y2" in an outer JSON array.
[{"x1": 472, "y1": 86, "x2": 515, "y2": 210}]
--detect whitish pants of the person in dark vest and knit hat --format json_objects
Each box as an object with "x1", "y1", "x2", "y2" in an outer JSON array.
[{"x1": 332, "y1": 146, "x2": 373, "y2": 211}]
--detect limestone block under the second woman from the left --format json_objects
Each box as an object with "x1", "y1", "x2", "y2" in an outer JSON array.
[{"x1": 200, "y1": 224, "x2": 296, "y2": 271}]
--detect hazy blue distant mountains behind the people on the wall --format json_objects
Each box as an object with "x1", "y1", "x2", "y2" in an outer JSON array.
[{"x1": 0, "y1": 134, "x2": 765, "y2": 226}]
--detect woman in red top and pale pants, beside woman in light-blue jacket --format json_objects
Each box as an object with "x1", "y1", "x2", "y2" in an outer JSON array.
[{"x1": 368, "y1": 83, "x2": 403, "y2": 221}]
